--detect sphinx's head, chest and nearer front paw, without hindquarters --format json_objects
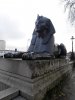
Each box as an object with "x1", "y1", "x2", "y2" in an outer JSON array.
[{"x1": 22, "y1": 16, "x2": 55, "y2": 60}]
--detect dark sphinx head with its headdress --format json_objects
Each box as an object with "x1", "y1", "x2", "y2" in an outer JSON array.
[{"x1": 35, "y1": 15, "x2": 55, "y2": 37}]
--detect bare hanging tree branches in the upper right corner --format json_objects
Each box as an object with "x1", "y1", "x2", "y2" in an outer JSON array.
[{"x1": 64, "y1": 0, "x2": 75, "y2": 24}]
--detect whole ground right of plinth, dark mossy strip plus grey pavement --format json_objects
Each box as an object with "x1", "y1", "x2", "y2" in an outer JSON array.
[{"x1": 45, "y1": 69, "x2": 75, "y2": 100}]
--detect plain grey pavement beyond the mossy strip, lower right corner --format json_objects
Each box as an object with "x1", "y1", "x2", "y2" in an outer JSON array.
[{"x1": 59, "y1": 69, "x2": 75, "y2": 100}]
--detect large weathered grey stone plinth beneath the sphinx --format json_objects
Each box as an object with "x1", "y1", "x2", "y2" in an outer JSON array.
[{"x1": 0, "y1": 58, "x2": 72, "y2": 100}]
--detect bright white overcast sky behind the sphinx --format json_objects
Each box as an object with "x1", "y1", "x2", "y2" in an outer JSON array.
[{"x1": 0, "y1": 0, "x2": 75, "y2": 51}]
